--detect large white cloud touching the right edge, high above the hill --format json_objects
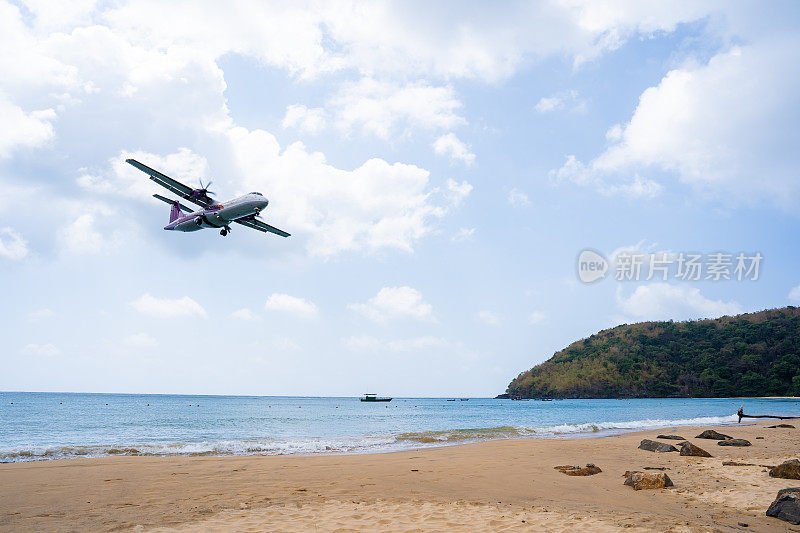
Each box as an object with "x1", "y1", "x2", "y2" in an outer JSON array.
[{"x1": 556, "y1": 36, "x2": 800, "y2": 210}]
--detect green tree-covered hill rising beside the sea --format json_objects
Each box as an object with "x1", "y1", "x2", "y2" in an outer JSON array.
[{"x1": 506, "y1": 307, "x2": 800, "y2": 398}]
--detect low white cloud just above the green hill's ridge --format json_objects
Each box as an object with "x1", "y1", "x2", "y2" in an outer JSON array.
[{"x1": 617, "y1": 282, "x2": 743, "y2": 320}]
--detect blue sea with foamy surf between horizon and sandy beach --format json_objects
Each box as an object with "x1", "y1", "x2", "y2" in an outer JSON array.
[{"x1": 0, "y1": 392, "x2": 800, "y2": 462}]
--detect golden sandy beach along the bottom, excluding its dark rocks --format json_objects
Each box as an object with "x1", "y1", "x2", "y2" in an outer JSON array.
[{"x1": 0, "y1": 422, "x2": 800, "y2": 532}]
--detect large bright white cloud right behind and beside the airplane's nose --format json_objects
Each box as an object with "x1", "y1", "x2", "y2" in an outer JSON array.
[{"x1": 225, "y1": 127, "x2": 471, "y2": 257}]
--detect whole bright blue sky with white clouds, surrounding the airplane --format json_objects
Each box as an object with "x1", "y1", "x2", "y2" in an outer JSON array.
[{"x1": 0, "y1": 0, "x2": 800, "y2": 396}]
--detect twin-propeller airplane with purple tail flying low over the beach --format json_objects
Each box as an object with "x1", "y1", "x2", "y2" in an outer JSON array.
[{"x1": 130, "y1": 159, "x2": 291, "y2": 237}]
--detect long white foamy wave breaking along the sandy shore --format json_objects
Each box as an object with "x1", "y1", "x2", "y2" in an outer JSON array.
[{"x1": 0, "y1": 415, "x2": 738, "y2": 462}]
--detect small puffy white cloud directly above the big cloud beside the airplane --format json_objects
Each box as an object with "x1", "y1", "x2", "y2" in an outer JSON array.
[{"x1": 329, "y1": 78, "x2": 474, "y2": 139}]
